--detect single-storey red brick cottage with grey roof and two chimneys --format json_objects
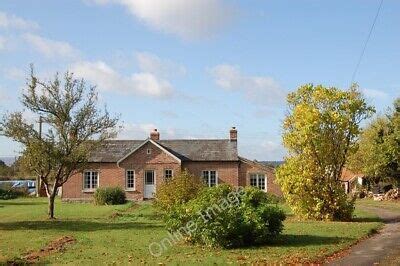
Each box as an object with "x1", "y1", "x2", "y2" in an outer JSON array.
[{"x1": 62, "y1": 127, "x2": 281, "y2": 201}]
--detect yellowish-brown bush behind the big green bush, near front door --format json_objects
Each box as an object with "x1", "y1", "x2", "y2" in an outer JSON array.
[{"x1": 155, "y1": 170, "x2": 204, "y2": 211}]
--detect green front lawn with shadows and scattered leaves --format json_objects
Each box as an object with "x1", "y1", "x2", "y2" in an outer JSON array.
[{"x1": 0, "y1": 198, "x2": 381, "y2": 265}]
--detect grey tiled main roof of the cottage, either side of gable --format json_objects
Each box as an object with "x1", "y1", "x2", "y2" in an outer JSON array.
[{"x1": 89, "y1": 139, "x2": 238, "y2": 162}]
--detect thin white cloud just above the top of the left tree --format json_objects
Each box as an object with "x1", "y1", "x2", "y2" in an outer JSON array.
[{"x1": 23, "y1": 33, "x2": 79, "y2": 59}]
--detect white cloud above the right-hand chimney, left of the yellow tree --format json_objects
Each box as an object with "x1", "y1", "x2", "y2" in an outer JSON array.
[{"x1": 210, "y1": 64, "x2": 286, "y2": 105}]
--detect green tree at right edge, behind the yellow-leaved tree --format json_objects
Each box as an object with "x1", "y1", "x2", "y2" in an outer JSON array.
[{"x1": 348, "y1": 98, "x2": 400, "y2": 184}]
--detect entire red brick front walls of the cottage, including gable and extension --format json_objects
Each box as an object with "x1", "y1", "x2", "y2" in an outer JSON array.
[{"x1": 62, "y1": 143, "x2": 282, "y2": 200}]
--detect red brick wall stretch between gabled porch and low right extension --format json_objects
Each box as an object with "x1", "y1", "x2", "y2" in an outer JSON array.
[{"x1": 182, "y1": 161, "x2": 239, "y2": 186}]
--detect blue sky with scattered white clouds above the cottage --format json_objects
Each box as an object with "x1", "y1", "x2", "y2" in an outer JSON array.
[{"x1": 0, "y1": 0, "x2": 400, "y2": 160}]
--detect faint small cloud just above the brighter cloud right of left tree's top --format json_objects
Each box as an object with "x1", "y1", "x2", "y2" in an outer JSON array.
[{"x1": 136, "y1": 52, "x2": 186, "y2": 77}]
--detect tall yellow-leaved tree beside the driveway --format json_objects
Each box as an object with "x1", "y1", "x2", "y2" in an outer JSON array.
[{"x1": 277, "y1": 84, "x2": 374, "y2": 220}]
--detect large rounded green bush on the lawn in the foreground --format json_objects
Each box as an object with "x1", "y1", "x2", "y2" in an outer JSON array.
[{"x1": 166, "y1": 185, "x2": 285, "y2": 248}]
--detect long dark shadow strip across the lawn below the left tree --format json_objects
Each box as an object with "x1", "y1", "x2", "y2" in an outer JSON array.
[{"x1": 0, "y1": 220, "x2": 163, "y2": 232}]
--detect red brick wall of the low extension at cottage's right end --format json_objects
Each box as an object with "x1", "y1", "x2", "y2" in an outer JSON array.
[{"x1": 239, "y1": 161, "x2": 282, "y2": 196}]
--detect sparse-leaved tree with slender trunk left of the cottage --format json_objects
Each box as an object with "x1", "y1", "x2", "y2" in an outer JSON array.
[{"x1": 0, "y1": 67, "x2": 118, "y2": 218}]
